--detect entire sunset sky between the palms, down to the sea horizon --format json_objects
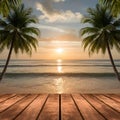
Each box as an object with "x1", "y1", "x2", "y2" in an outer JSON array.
[{"x1": 0, "y1": 0, "x2": 119, "y2": 59}]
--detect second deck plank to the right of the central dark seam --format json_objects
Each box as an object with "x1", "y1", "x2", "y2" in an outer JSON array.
[{"x1": 73, "y1": 94, "x2": 105, "y2": 120}]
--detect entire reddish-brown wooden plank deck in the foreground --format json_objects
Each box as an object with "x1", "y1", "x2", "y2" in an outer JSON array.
[{"x1": 0, "y1": 94, "x2": 120, "y2": 120}]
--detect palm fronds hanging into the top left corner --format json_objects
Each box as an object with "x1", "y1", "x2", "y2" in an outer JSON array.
[{"x1": 0, "y1": 0, "x2": 21, "y2": 16}]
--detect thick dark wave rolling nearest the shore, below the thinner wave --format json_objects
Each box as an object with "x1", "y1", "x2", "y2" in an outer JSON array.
[{"x1": 2, "y1": 73, "x2": 115, "y2": 77}]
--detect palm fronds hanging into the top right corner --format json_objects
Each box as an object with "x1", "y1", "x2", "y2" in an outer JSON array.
[{"x1": 99, "y1": 0, "x2": 120, "y2": 16}]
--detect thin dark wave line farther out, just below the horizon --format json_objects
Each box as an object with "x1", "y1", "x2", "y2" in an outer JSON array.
[{"x1": 0, "y1": 64, "x2": 120, "y2": 67}]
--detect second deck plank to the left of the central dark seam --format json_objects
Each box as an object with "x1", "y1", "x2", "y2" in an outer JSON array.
[{"x1": 15, "y1": 94, "x2": 47, "y2": 120}]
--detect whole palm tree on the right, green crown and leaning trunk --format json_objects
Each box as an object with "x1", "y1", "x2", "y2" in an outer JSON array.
[{"x1": 80, "y1": 4, "x2": 120, "y2": 80}]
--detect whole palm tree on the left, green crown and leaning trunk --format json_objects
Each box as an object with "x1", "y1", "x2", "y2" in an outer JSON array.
[{"x1": 0, "y1": 5, "x2": 40, "y2": 80}]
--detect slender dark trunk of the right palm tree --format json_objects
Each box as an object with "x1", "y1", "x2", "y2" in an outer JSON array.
[{"x1": 107, "y1": 41, "x2": 120, "y2": 81}]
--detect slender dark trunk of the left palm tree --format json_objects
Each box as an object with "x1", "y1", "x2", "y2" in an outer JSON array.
[{"x1": 0, "y1": 39, "x2": 14, "y2": 82}]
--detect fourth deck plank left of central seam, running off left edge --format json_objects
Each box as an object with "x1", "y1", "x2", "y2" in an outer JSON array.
[{"x1": 0, "y1": 95, "x2": 25, "y2": 112}]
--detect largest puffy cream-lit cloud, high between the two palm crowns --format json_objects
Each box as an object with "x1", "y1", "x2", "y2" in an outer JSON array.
[{"x1": 36, "y1": 0, "x2": 83, "y2": 22}]
